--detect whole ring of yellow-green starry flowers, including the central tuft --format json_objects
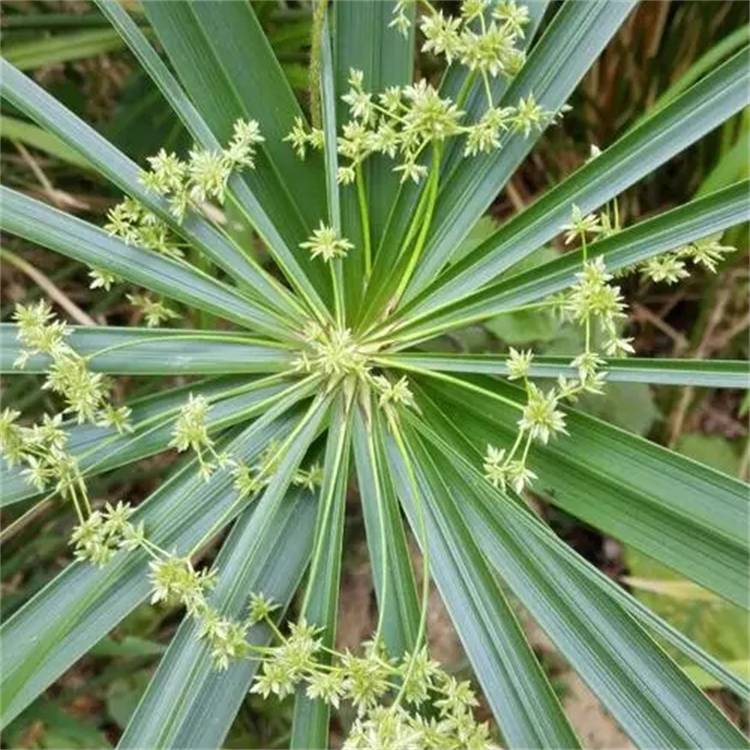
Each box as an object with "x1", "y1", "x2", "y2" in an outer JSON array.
[{"x1": 0, "y1": 0, "x2": 733, "y2": 750}]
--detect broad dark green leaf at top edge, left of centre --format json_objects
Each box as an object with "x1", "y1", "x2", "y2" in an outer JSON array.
[{"x1": 139, "y1": 0, "x2": 328, "y2": 306}]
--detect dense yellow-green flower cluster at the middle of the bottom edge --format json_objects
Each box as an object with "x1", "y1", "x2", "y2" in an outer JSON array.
[{"x1": 250, "y1": 600, "x2": 492, "y2": 750}]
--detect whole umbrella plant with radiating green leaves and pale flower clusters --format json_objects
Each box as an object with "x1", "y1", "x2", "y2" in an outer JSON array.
[{"x1": 0, "y1": 0, "x2": 750, "y2": 750}]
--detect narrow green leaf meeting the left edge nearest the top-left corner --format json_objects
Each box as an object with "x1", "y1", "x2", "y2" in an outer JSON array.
[{"x1": 0, "y1": 60, "x2": 292, "y2": 309}]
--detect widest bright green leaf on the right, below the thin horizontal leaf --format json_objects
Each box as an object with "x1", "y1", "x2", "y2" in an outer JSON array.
[{"x1": 419, "y1": 376, "x2": 750, "y2": 608}]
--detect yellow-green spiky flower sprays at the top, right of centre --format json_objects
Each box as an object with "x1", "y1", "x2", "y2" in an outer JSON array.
[{"x1": 285, "y1": 0, "x2": 555, "y2": 185}]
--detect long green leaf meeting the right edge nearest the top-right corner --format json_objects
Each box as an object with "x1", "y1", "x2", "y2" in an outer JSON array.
[{"x1": 410, "y1": 47, "x2": 750, "y2": 315}]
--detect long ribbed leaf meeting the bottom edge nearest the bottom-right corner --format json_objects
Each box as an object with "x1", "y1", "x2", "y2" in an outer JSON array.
[{"x1": 408, "y1": 414, "x2": 745, "y2": 748}]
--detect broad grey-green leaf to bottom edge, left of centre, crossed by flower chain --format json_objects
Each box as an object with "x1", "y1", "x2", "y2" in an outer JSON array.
[{"x1": 119, "y1": 489, "x2": 315, "y2": 748}]
